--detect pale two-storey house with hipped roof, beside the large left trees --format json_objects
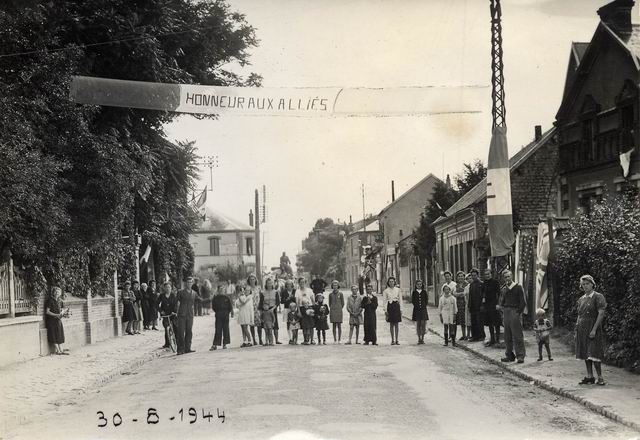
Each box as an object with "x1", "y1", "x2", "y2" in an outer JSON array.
[{"x1": 189, "y1": 207, "x2": 256, "y2": 273}]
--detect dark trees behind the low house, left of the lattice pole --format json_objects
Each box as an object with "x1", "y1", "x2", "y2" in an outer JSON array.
[{"x1": 413, "y1": 159, "x2": 487, "y2": 266}]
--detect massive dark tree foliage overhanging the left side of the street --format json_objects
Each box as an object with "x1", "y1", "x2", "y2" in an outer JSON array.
[{"x1": 0, "y1": 0, "x2": 260, "y2": 293}]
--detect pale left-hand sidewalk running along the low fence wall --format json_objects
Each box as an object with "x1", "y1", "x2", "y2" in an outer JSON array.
[{"x1": 0, "y1": 315, "x2": 213, "y2": 438}]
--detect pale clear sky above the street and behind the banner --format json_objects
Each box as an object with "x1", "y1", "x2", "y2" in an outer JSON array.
[{"x1": 166, "y1": 0, "x2": 637, "y2": 266}]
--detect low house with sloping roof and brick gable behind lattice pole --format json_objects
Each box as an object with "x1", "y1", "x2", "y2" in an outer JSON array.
[{"x1": 430, "y1": 126, "x2": 558, "y2": 314}]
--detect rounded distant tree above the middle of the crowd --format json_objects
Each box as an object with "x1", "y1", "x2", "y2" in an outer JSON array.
[{"x1": 301, "y1": 218, "x2": 348, "y2": 280}]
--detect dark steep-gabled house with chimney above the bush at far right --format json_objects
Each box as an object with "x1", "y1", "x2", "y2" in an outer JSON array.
[{"x1": 555, "y1": 0, "x2": 640, "y2": 217}]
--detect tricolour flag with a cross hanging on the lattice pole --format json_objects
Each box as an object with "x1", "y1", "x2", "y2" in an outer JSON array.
[{"x1": 487, "y1": 127, "x2": 514, "y2": 257}]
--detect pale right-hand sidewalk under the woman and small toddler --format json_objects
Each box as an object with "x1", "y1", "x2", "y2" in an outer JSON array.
[{"x1": 403, "y1": 302, "x2": 640, "y2": 431}]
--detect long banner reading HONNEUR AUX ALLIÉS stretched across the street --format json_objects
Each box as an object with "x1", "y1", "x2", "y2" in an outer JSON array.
[{"x1": 70, "y1": 76, "x2": 488, "y2": 117}]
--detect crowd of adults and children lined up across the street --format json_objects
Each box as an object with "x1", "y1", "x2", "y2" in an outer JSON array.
[{"x1": 107, "y1": 269, "x2": 606, "y2": 384}]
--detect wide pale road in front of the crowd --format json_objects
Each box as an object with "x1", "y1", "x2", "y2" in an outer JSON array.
[{"x1": 7, "y1": 302, "x2": 638, "y2": 440}]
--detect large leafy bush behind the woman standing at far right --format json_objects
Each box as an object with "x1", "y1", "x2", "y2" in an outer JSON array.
[{"x1": 555, "y1": 190, "x2": 640, "y2": 371}]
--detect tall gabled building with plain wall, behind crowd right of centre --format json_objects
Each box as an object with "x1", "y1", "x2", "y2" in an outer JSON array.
[{"x1": 378, "y1": 174, "x2": 441, "y2": 295}]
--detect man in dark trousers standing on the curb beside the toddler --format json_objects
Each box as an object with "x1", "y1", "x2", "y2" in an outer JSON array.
[{"x1": 500, "y1": 270, "x2": 526, "y2": 364}]
